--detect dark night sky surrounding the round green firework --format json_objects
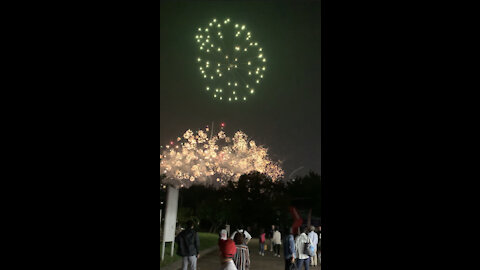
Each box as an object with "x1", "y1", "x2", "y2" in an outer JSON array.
[{"x1": 160, "y1": 1, "x2": 320, "y2": 176}]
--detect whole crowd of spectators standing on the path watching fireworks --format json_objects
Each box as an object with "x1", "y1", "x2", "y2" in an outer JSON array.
[{"x1": 175, "y1": 221, "x2": 321, "y2": 270}]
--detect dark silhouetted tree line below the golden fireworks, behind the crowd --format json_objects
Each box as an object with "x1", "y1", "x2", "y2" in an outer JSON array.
[{"x1": 160, "y1": 172, "x2": 321, "y2": 234}]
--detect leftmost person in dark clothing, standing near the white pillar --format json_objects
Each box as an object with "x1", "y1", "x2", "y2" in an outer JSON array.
[{"x1": 175, "y1": 220, "x2": 200, "y2": 270}]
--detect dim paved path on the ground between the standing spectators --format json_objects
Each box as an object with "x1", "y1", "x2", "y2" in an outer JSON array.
[{"x1": 162, "y1": 239, "x2": 320, "y2": 270}]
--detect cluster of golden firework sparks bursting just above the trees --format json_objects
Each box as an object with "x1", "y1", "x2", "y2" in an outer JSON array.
[{"x1": 160, "y1": 125, "x2": 284, "y2": 187}]
